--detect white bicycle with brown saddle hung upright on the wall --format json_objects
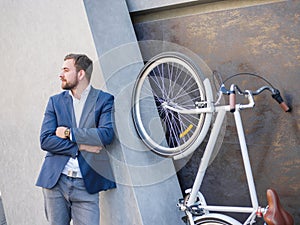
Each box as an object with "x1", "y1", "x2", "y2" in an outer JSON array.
[{"x1": 132, "y1": 52, "x2": 294, "y2": 225}]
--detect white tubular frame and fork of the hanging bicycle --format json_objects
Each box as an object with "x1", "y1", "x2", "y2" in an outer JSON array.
[{"x1": 171, "y1": 84, "x2": 265, "y2": 225}]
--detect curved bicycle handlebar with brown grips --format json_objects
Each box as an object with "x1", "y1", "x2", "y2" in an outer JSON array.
[{"x1": 220, "y1": 84, "x2": 291, "y2": 112}]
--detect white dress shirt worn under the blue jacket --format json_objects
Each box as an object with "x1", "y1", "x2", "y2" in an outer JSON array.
[{"x1": 62, "y1": 85, "x2": 91, "y2": 178}]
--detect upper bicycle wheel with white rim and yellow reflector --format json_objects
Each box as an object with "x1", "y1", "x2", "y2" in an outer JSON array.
[{"x1": 132, "y1": 52, "x2": 212, "y2": 157}]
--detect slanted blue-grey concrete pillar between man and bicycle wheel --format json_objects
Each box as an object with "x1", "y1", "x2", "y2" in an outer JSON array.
[{"x1": 84, "y1": 0, "x2": 183, "y2": 225}]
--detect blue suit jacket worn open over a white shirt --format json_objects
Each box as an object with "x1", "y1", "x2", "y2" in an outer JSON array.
[{"x1": 36, "y1": 87, "x2": 116, "y2": 194}]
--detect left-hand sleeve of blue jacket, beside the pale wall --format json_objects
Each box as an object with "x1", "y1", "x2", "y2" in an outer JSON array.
[{"x1": 40, "y1": 97, "x2": 78, "y2": 158}]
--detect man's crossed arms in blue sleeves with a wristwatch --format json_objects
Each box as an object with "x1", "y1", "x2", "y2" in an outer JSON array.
[{"x1": 40, "y1": 92, "x2": 114, "y2": 158}]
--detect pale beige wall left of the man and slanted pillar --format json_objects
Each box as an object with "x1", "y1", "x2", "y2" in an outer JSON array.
[{"x1": 0, "y1": 0, "x2": 101, "y2": 225}]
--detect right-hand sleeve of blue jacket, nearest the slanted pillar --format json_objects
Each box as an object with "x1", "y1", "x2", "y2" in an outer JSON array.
[{"x1": 71, "y1": 92, "x2": 114, "y2": 146}]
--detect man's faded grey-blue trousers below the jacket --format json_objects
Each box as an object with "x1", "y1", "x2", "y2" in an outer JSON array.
[{"x1": 43, "y1": 175, "x2": 100, "y2": 225}]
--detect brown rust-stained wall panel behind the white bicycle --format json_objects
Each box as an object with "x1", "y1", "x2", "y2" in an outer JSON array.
[{"x1": 133, "y1": 1, "x2": 300, "y2": 224}]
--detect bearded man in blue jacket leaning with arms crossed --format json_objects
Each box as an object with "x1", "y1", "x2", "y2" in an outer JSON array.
[{"x1": 37, "y1": 54, "x2": 116, "y2": 225}]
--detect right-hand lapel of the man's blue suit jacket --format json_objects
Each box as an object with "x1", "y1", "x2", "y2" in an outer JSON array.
[{"x1": 79, "y1": 87, "x2": 99, "y2": 127}]
